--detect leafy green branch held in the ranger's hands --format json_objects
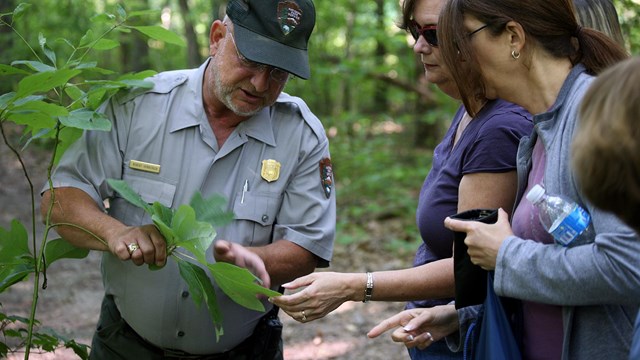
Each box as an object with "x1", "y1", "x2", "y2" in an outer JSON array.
[{"x1": 107, "y1": 179, "x2": 281, "y2": 339}]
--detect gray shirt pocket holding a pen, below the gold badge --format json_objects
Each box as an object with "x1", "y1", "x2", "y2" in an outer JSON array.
[{"x1": 233, "y1": 191, "x2": 282, "y2": 246}]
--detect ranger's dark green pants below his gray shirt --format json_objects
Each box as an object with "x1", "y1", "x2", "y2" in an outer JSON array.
[{"x1": 89, "y1": 296, "x2": 283, "y2": 360}]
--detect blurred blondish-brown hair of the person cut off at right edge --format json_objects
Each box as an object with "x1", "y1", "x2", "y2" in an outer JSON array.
[{"x1": 572, "y1": 57, "x2": 640, "y2": 232}]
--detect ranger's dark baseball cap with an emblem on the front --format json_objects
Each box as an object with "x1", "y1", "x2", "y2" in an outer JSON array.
[{"x1": 227, "y1": 0, "x2": 316, "y2": 79}]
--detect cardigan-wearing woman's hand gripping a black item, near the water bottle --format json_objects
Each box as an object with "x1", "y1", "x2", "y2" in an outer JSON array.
[{"x1": 444, "y1": 209, "x2": 513, "y2": 270}]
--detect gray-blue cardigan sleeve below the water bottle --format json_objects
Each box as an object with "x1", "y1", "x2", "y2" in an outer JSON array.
[{"x1": 494, "y1": 206, "x2": 640, "y2": 306}]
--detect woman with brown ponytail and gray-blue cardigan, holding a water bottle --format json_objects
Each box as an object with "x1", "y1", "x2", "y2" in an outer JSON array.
[{"x1": 404, "y1": 0, "x2": 640, "y2": 359}]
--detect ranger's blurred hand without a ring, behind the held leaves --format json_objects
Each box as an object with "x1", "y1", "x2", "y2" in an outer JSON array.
[{"x1": 213, "y1": 240, "x2": 271, "y2": 288}]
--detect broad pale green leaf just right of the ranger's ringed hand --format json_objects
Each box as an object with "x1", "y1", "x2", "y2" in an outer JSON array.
[{"x1": 171, "y1": 205, "x2": 216, "y2": 265}]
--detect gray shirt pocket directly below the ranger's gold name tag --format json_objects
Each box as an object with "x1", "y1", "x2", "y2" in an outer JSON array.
[{"x1": 109, "y1": 174, "x2": 176, "y2": 226}]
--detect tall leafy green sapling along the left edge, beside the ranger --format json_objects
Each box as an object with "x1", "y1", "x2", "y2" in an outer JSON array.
[{"x1": 0, "y1": 3, "x2": 191, "y2": 359}]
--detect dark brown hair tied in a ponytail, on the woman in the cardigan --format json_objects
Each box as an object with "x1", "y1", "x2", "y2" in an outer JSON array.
[{"x1": 438, "y1": 0, "x2": 628, "y2": 116}]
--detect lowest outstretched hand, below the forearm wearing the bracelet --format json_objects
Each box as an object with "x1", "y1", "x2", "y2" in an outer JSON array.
[{"x1": 367, "y1": 305, "x2": 458, "y2": 349}]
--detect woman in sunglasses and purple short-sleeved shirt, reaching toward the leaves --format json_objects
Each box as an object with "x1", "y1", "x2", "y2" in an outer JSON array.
[{"x1": 273, "y1": 0, "x2": 533, "y2": 359}]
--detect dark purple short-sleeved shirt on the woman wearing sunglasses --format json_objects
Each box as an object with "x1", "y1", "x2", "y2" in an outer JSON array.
[{"x1": 408, "y1": 100, "x2": 533, "y2": 308}]
